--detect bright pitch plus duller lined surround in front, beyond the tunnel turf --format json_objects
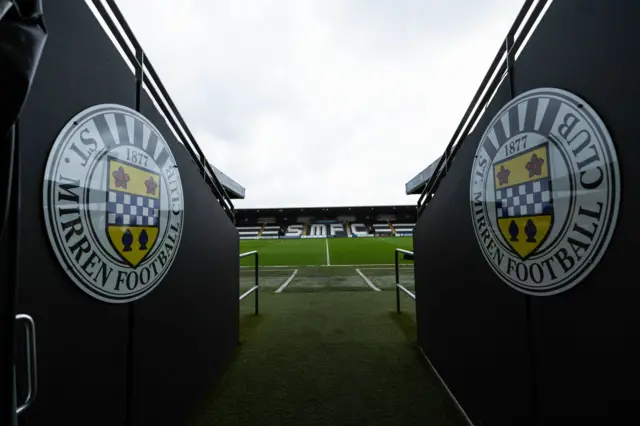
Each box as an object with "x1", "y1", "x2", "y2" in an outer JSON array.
[{"x1": 240, "y1": 237, "x2": 413, "y2": 293}]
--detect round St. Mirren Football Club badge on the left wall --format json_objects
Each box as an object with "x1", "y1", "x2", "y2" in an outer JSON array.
[{"x1": 43, "y1": 104, "x2": 184, "y2": 303}]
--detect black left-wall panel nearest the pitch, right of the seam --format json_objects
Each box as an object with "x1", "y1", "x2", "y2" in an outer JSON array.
[{"x1": 133, "y1": 94, "x2": 240, "y2": 426}]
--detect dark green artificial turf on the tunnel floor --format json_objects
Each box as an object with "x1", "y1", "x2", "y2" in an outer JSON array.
[{"x1": 196, "y1": 291, "x2": 465, "y2": 426}]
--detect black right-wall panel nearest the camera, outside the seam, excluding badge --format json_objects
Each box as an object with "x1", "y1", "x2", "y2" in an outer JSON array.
[{"x1": 514, "y1": 0, "x2": 640, "y2": 425}]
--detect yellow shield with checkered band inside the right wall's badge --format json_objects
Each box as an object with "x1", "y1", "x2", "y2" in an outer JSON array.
[{"x1": 493, "y1": 143, "x2": 553, "y2": 260}]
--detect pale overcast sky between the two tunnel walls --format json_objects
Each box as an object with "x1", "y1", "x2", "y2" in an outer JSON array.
[{"x1": 117, "y1": 0, "x2": 523, "y2": 208}]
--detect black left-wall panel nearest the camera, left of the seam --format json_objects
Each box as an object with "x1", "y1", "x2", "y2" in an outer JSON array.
[{"x1": 18, "y1": 0, "x2": 135, "y2": 426}]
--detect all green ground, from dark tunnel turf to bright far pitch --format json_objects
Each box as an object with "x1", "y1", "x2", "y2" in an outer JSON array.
[{"x1": 195, "y1": 237, "x2": 465, "y2": 426}]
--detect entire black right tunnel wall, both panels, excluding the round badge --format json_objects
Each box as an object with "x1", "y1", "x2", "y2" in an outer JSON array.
[{"x1": 415, "y1": 0, "x2": 640, "y2": 425}]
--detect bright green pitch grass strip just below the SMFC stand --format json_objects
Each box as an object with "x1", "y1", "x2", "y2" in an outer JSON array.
[{"x1": 240, "y1": 237, "x2": 413, "y2": 266}]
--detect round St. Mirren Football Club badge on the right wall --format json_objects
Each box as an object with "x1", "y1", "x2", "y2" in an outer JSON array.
[{"x1": 469, "y1": 88, "x2": 620, "y2": 296}]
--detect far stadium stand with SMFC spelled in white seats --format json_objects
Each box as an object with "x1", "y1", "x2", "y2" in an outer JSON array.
[{"x1": 236, "y1": 206, "x2": 416, "y2": 239}]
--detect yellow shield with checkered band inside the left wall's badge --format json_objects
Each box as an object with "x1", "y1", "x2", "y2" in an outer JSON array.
[{"x1": 106, "y1": 157, "x2": 161, "y2": 268}]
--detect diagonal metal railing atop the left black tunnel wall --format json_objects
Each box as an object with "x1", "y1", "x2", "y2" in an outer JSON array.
[{"x1": 91, "y1": 0, "x2": 235, "y2": 221}]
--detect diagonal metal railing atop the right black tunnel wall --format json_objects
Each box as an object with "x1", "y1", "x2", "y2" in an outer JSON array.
[{"x1": 418, "y1": 0, "x2": 550, "y2": 217}]
